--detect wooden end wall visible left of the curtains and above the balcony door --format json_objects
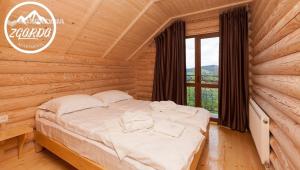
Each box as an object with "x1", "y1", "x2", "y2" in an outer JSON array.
[{"x1": 134, "y1": 11, "x2": 219, "y2": 100}]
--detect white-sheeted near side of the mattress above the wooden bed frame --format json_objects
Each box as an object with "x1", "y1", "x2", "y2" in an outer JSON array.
[{"x1": 36, "y1": 116, "x2": 154, "y2": 170}]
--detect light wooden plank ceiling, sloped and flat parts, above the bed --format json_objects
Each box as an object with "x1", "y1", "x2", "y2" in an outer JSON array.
[{"x1": 0, "y1": 0, "x2": 251, "y2": 60}]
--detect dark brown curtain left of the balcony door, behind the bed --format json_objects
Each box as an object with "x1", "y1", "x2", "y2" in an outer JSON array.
[{"x1": 152, "y1": 21, "x2": 186, "y2": 105}]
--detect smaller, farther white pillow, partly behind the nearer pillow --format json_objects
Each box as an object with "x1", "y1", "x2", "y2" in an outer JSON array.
[{"x1": 93, "y1": 90, "x2": 133, "y2": 104}]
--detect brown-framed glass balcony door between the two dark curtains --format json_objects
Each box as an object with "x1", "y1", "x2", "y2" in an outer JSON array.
[{"x1": 186, "y1": 34, "x2": 219, "y2": 118}]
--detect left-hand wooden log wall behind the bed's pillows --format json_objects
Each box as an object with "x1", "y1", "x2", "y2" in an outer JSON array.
[{"x1": 0, "y1": 47, "x2": 134, "y2": 161}]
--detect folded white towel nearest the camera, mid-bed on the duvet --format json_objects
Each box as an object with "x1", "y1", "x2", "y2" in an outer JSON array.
[{"x1": 120, "y1": 111, "x2": 154, "y2": 133}]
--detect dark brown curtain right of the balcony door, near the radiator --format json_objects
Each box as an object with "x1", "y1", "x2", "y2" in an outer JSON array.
[{"x1": 219, "y1": 7, "x2": 249, "y2": 132}]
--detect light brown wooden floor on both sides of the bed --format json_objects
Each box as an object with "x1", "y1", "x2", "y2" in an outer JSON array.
[{"x1": 0, "y1": 124, "x2": 263, "y2": 170}]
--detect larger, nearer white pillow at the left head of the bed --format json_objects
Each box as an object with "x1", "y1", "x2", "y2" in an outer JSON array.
[{"x1": 39, "y1": 94, "x2": 107, "y2": 116}]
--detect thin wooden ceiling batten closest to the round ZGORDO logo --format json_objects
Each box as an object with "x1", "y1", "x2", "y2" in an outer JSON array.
[{"x1": 61, "y1": 0, "x2": 104, "y2": 54}]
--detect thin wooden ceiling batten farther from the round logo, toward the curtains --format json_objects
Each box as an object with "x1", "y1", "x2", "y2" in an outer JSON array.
[{"x1": 102, "y1": 0, "x2": 159, "y2": 58}]
